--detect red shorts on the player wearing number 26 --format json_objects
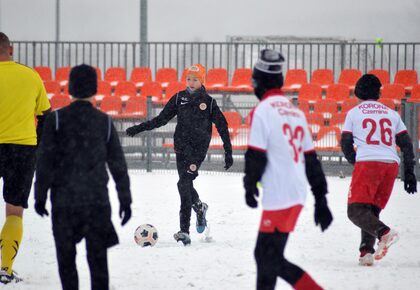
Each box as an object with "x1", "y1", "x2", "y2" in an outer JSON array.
[{"x1": 348, "y1": 161, "x2": 398, "y2": 209}]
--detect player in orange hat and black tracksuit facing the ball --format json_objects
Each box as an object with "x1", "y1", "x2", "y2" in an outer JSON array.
[{"x1": 127, "y1": 64, "x2": 233, "y2": 245}]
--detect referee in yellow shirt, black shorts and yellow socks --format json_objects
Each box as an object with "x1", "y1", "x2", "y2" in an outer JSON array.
[{"x1": 0, "y1": 32, "x2": 51, "y2": 284}]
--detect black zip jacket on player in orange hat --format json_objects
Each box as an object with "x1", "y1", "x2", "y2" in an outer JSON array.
[{"x1": 139, "y1": 87, "x2": 232, "y2": 158}]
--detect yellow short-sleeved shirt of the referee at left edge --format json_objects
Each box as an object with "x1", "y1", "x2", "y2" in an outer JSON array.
[{"x1": 0, "y1": 61, "x2": 50, "y2": 145}]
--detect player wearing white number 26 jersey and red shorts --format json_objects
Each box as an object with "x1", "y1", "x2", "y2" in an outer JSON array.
[{"x1": 341, "y1": 74, "x2": 417, "y2": 266}]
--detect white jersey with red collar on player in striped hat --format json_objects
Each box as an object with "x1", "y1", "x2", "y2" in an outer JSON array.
[{"x1": 248, "y1": 91, "x2": 314, "y2": 210}]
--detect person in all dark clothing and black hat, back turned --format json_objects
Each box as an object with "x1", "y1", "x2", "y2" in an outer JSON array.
[{"x1": 35, "y1": 65, "x2": 131, "y2": 290}]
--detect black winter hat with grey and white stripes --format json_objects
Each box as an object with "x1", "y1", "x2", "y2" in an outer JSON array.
[{"x1": 252, "y1": 49, "x2": 284, "y2": 90}]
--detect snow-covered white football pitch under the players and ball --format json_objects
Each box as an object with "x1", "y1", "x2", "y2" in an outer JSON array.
[{"x1": 0, "y1": 172, "x2": 420, "y2": 290}]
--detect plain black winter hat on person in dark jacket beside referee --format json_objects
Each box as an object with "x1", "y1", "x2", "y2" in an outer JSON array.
[{"x1": 69, "y1": 64, "x2": 98, "y2": 99}]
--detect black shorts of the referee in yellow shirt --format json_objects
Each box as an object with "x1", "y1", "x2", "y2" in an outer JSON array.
[{"x1": 0, "y1": 144, "x2": 36, "y2": 208}]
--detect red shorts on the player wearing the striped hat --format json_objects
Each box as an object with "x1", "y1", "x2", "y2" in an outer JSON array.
[{"x1": 260, "y1": 205, "x2": 303, "y2": 233}]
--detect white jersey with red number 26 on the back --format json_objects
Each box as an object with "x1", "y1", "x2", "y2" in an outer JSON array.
[{"x1": 343, "y1": 101, "x2": 407, "y2": 163}]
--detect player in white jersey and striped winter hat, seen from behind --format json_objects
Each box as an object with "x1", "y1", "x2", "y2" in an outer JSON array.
[{"x1": 244, "y1": 49, "x2": 332, "y2": 290}]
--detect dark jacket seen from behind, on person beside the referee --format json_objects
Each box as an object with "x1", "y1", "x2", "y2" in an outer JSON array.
[{"x1": 35, "y1": 101, "x2": 131, "y2": 210}]
